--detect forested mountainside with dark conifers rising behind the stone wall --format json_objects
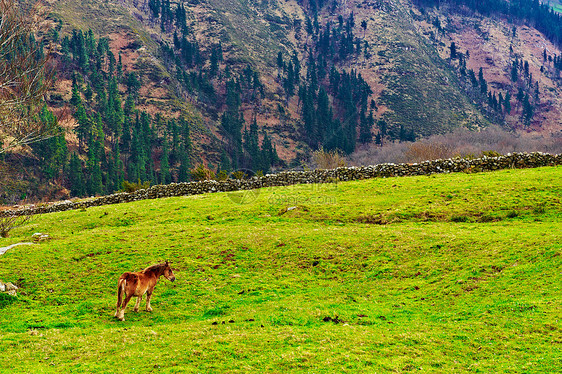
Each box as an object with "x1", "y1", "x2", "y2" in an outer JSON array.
[{"x1": 0, "y1": 0, "x2": 562, "y2": 203}]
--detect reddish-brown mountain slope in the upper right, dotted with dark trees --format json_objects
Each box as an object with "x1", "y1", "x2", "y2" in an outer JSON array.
[{"x1": 415, "y1": 0, "x2": 562, "y2": 133}]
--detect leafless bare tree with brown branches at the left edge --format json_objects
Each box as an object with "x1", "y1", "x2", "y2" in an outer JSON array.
[{"x1": 0, "y1": 0, "x2": 58, "y2": 154}]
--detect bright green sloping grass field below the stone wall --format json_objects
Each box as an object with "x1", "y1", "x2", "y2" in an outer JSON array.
[{"x1": 0, "y1": 167, "x2": 562, "y2": 373}]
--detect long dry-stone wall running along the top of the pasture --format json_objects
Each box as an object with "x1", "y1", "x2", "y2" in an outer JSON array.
[{"x1": 0, "y1": 152, "x2": 562, "y2": 217}]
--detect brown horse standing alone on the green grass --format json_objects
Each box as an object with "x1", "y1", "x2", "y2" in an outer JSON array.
[{"x1": 115, "y1": 261, "x2": 176, "y2": 321}]
